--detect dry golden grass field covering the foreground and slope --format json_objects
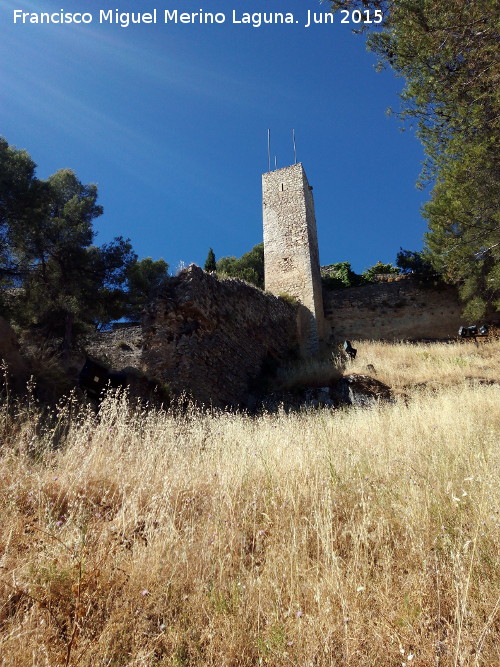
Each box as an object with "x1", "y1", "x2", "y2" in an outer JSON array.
[{"x1": 0, "y1": 341, "x2": 500, "y2": 667}]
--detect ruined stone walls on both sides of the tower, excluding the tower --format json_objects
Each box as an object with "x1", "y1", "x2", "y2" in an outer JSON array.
[{"x1": 77, "y1": 266, "x2": 500, "y2": 407}]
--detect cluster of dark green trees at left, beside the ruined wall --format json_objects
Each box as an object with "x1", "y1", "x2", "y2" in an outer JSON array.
[{"x1": 0, "y1": 139, "x2": 168, "y2": 350}]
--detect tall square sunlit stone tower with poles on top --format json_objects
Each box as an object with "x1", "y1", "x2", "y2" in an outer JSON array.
[{"x1": 262, "y1": 163, "x2": 324, "y2": 355}]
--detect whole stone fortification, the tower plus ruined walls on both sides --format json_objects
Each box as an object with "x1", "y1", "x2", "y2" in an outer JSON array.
[{"x1": 80, "y1": 164, "x2": 499, "y2": 408}]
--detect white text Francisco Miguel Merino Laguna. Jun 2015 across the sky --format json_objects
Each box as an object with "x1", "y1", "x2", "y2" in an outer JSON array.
[{"x1": 12, "y1": 9, "x2": 383, "y2": 28}]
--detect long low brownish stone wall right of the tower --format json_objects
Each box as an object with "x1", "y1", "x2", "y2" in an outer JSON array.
[{"x1": 323, "y1": 279, "x2": 498, "y2": 341}]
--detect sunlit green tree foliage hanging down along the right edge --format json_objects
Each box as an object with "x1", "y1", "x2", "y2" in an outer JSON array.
[{"x1": 330, "y1": 0, "x2": 500, "y2": 317}]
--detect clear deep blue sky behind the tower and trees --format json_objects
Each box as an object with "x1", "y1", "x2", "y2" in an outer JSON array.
[{"x1": 0, "y1": 0, "x2": 429, "y2": 272}]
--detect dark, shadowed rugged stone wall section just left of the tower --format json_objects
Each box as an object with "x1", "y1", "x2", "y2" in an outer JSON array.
[{"x1": 142, "y1": 265, "x2": 297, "y2": 407}]
